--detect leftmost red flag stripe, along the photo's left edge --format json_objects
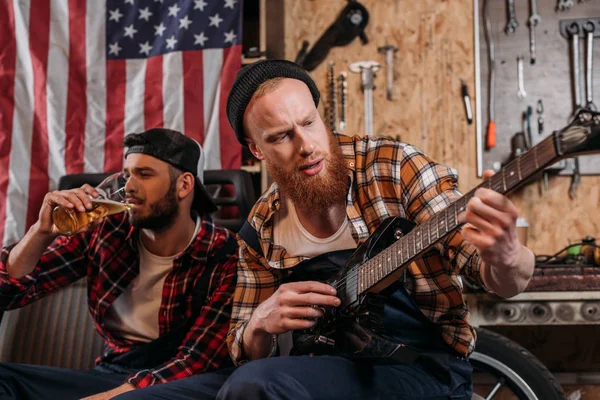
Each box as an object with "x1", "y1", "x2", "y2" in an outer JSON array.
[{"x1": 0, "y1": 1, "x2": 17, "y2": 243}]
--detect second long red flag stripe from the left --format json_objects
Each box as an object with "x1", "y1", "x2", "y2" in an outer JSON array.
[{"x1": 26, "y1": 0, "x2": 50, "y2": 230}]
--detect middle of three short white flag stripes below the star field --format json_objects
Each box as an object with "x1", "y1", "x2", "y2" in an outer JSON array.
[{"x1": 163, "y1": 51, "x2": 184, "y2": 132}]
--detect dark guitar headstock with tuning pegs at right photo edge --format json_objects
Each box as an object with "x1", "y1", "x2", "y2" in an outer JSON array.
[{"x1": 554, "y1": 108, "x2": 600, "y2": 158}]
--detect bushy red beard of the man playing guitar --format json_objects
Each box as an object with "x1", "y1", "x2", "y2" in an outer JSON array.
[{"x1": 266, "y1": 135, "x2": 348, "y2": 210}]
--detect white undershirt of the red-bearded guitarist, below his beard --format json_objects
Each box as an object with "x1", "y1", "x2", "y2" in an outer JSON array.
[{"x1": 273, "y1": 195, "x2": 356, "y2": 257}]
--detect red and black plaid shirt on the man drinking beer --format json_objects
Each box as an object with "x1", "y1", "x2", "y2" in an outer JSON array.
[{"x1": 0, "y1": 214, "x2": 238, "y2": 388}]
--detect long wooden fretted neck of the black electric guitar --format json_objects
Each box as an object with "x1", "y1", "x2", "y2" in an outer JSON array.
[{"x1": 358, "y1": 135, "x2": 560, "y2": 294}]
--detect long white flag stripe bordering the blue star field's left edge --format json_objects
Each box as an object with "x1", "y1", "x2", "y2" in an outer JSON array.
[{"x1": 84, "y1": 0, "x2": 106, "y2": 172}]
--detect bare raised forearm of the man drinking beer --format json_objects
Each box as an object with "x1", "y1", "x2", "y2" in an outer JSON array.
[{"x1": 6, "y1": 223, "x2": 56, "y2": 279}]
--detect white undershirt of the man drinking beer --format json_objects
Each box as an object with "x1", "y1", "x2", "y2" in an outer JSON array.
[{"x1": 105, "y1": 217, "x2": 201, "y2": 342}]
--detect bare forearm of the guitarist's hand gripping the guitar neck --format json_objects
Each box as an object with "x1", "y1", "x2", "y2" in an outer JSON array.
[{"x1": 481, "y1": 246, "x2": 535, "y2": 298}]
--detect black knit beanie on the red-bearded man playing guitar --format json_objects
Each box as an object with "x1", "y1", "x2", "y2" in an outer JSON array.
[{"x1": 227, "y1": 60, "x2": 321, "y2": 147}]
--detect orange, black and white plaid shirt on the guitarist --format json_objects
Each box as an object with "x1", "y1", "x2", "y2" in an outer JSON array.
[{"x1": 227, "y1": 134, "x2": 483, "y2": 364}]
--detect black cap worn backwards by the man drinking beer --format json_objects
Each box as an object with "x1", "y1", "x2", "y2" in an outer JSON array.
[{"x1": 125, "y1": 128, "x2": 217, "y2": 214}]
